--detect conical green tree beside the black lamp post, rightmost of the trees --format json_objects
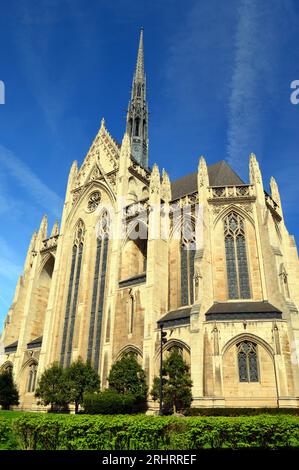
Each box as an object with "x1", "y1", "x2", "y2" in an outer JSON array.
[{"x1": 151, "y1": 348, "x2": 192, "y2": 413}]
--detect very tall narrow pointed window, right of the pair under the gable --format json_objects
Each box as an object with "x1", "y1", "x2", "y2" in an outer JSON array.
[{"x1": 87, "y1": 210, "x2": 110, "y2": 370}]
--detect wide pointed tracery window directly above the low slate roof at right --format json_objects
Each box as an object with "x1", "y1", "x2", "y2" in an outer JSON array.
[{"x1": 224, "y1": 212, "x2": 250, "y2": 299}]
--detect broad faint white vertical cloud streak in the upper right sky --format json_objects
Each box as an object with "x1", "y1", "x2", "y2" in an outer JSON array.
[{"x1": 227, "y1": 0, "x2": 296, "y2": 173}]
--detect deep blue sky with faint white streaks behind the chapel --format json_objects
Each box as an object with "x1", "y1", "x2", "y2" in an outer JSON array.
[{"x1": 0, "y1": 0, "x2": 299, "y2": 325}]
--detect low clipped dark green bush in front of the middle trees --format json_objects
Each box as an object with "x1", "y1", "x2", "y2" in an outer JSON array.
[{"x1": 83, "y1": 389, "x2": 135, "y2": 415}]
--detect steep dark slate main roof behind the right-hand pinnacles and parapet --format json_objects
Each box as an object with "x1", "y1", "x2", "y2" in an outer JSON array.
[{"x1": 171, "y1": 160, "x2": 245, "y2": 200}]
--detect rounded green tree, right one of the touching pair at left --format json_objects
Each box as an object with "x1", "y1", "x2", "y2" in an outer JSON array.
[{"x1": 65, "y1": 358, "x2": 100, "y2": 413}]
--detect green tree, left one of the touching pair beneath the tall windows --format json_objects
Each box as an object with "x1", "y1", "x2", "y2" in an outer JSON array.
[{"x1": 35, "y1": 362, "x2": 69, "y2": 411}]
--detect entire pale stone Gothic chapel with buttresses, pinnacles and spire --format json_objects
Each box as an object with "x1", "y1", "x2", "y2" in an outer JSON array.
[{"x1": 0, "y1": 30, "x2": 299, "y2": 410}]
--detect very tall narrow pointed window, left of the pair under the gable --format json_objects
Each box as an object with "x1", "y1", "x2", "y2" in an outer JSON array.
[{"x1": 60, "y1": 220, "x2": 85, "y2": 366}]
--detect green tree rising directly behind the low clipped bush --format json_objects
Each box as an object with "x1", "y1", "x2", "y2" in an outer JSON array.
[{"x1": 108, "y1": 353, "x2": 147, "y2": 410}]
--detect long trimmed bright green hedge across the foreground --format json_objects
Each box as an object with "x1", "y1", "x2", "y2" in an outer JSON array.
[{"x1": 6, "y1": 415, "x2": 299, "y2": 450}]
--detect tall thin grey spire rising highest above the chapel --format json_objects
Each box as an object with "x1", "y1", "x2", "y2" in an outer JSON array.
[{"x1": 126, "y1": 28, "x2": 148, "y2": 168}]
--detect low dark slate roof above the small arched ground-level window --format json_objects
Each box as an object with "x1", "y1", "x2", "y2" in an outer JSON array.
[{"x1": 206, "y1": 301, "x2": 281, "y2": 320}]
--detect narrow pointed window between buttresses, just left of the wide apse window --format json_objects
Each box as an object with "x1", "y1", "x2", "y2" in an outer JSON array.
[{"x1": 181, "y1": 229, "x2": 196, "y2": 307}]
